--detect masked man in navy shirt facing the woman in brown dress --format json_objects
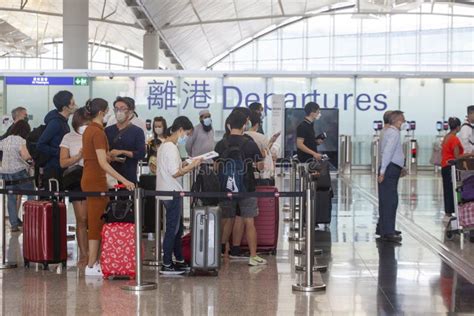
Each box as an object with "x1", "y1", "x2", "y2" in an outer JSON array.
[{"x1": 105, "y1": 97, "x2": 145, "y2": 183}]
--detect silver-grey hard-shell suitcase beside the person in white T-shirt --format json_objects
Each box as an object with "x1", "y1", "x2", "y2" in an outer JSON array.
[{"x1": 191, "y1": 206, "x2": 221, "y2": 275}]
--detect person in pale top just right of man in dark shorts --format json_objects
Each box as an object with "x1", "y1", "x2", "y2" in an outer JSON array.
[{"x1": 245, "y1": 112, "x2": 280, "y2": 185}]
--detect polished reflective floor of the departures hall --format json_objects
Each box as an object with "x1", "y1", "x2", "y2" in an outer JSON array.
[{"x1": 0, "y1": 174, "x2": 474, "y2": 315}]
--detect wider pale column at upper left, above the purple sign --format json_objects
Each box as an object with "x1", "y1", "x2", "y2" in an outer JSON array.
[{"x1": 63, "y1": 0, "x2": 89, "y2": 69}]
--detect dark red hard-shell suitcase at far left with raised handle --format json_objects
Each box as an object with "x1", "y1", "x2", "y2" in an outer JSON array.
[{"x1": 23, "y1": 201, "x2": 67, "y2": 270}]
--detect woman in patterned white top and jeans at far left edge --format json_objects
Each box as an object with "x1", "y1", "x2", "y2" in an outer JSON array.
[{"x1": 0, "y1": 121, "x2": 34, "y2": 232}]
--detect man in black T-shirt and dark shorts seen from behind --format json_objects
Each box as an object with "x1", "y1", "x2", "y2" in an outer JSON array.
[{"x1": 215, "y1": 111, "x2": 266, "y2": 265}]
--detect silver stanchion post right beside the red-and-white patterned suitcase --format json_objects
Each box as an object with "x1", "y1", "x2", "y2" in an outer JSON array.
[{"x1": 122, "y1": 188, "x2": 157, "y2": 291}]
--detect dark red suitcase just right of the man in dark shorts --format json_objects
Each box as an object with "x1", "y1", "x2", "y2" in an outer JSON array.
[{"x1": 241, "y1": 186, "x2": 280, "y2": 254}]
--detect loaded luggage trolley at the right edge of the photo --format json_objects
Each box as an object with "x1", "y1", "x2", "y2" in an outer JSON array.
[{"x1": 445, "y1": 158, "x2": 474, "y2": 248}]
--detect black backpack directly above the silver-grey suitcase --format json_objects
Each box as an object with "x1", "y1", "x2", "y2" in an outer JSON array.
[{"x1": 191, "y1": 165, "x2": 221, "y2": 206}]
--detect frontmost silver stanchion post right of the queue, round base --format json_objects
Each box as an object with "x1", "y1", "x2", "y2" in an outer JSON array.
[{"x1": 292, "y1": 180, "x2": 326, "y2": 292}]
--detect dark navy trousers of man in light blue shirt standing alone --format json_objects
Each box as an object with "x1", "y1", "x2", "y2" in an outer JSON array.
[{"x1": 379, "y1": 163, "x2": 402, "y2": 236}]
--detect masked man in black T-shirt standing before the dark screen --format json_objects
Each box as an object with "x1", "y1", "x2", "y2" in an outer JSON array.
[{"x1": 296, "y1": 102, "x2": 322, "y2": 162}]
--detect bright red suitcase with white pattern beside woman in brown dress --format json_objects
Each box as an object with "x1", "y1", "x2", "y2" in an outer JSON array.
[{"x1": 100, "y1": 223, "x2": 136, "y2": 279}]
